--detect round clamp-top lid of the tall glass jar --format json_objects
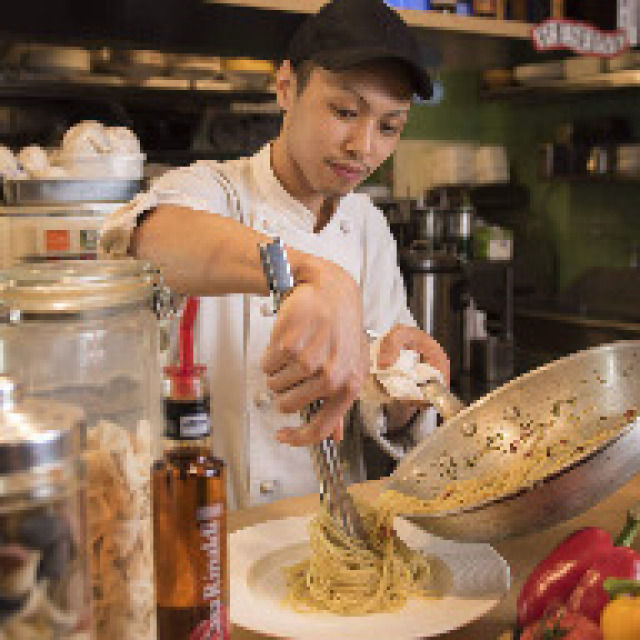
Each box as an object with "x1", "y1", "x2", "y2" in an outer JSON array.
[{"x1": 0, "y1": 258, "x2": 156, "y2": 318}]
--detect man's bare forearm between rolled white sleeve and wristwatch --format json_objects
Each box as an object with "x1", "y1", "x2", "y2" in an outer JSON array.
[{"x1": 132, "y1": 205, "x2": 312, "y2": 296}]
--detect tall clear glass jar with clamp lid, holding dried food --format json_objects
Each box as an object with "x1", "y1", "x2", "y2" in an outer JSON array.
[{"x1": 0, "y1": 259, "x2": 162, "y2": 640}]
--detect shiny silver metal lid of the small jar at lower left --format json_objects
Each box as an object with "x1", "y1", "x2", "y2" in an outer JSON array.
[{"x1": 0, "y1": 376, "x2": 85, "y2": 496}]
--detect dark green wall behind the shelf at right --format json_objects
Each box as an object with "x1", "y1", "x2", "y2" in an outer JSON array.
[{"x1": 404, "y1": 72, "x2": 640, "y2": 291}]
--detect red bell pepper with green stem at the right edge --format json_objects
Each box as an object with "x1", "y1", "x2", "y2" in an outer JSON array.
[{"x1": 567, "y1": 512, "x2": 640, "y2": 622}]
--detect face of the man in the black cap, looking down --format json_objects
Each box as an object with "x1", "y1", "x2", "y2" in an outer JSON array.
[{"x1": 278, "y1": 61, "x2": 411, "y2": 197}]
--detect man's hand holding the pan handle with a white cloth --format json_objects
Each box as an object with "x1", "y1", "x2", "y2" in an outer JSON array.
[{"x1": 378, "y1": 324, "x2": 449, "y2": 431}]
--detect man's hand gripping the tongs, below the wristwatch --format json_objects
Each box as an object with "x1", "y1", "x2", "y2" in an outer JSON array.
[{"x1": 262, "y1": 258, "x2": 369, "y2": 446}]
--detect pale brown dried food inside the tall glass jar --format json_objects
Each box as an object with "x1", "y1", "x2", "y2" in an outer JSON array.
[{"x1": 87, "y1": 420, "x2": 156, "y2": 640}]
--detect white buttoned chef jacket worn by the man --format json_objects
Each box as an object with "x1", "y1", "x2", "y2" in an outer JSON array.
[{"x1": 101, "y1": 144, "x2": 415, "y2": 508}]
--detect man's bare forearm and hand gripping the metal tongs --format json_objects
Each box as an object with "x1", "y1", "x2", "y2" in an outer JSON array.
[{"x1": 131, "y1": 205, "x2": 368, "y2": 446}]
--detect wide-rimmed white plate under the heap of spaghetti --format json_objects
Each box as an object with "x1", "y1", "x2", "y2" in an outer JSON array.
[{"x1": 230, "y1": 516, "x2": 509, "y2": 640}]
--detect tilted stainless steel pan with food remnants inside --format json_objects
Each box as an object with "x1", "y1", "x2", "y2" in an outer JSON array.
[{"x1": 387, "y1": 340, "x2": 640, "y2": 542}]
